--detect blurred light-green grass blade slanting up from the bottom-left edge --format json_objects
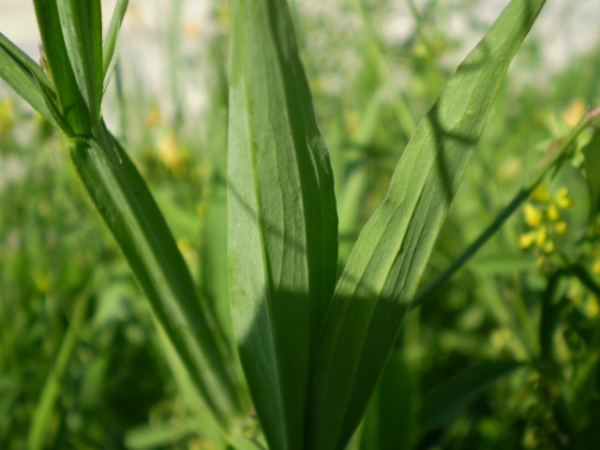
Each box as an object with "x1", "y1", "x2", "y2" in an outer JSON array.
[{"x1": 27, "y1": 282, "x2": 93, "y2": 450}]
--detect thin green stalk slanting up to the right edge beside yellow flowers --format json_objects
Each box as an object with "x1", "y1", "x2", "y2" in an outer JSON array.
[{"x1": 412, "y1": 105, "x2": 600, "y2": 308}]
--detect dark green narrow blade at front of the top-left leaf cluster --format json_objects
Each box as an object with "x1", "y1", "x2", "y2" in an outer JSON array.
[{"x1": 34, "y1": 0, "x2": 92, "y2": 136}]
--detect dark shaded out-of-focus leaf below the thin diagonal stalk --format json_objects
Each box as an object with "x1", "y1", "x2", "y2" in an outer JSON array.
[{"x1": 419, "y1": 361, "x2": 524, "y2": 431}]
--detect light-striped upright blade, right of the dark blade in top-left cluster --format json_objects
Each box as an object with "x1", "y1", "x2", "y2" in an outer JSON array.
[{"x1": 56, "y1": 0, "x2": 104, "y2": 126}]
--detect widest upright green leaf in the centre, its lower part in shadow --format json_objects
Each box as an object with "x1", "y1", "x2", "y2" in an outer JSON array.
[{"x1": 227, "y1": 0, "x2": 337, "y2": 449}]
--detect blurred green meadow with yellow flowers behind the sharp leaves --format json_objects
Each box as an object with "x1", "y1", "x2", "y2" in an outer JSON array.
[{"x1": 0, "y1": 0, "x2": 600, "y2": 450}]
